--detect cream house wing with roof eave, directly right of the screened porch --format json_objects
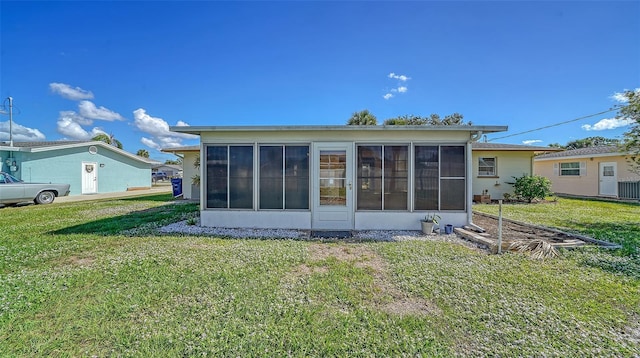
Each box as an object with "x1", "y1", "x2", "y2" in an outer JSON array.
[{"x1": 472, "y1": 142, "x2": 562, "y2": 200}]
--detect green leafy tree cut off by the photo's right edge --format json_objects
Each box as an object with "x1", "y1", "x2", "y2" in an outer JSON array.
[{"x1": 616, "y1": 89, "x2": 640, "y2": 174}]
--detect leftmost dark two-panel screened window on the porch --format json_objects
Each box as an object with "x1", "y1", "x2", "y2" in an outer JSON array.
[{"x1": 206, "y1": 145, "x2": 253, "y2": 209}]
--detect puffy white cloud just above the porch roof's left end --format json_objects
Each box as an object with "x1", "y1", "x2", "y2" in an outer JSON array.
[{"x1": 133, "y1": 108, "x2": 198, "y2": 149}]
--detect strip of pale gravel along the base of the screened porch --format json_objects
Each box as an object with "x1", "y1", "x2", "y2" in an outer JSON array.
[{"x1": 159, "y1": 220, "x2": 483, "y2": 249}]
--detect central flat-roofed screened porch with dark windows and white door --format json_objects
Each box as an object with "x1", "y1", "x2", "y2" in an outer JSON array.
[{"x1": 171, "y1": 125, "x2": 507, "y2": 230}]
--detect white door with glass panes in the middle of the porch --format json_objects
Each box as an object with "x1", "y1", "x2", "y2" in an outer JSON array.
[{"x1": 311, "y1": 143, "x2": 353, "y2": 230}]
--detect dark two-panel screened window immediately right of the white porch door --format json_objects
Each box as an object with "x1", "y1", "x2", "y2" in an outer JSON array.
[{"x1": 356, "y1": 145, "x2": 409, "y2": 210}]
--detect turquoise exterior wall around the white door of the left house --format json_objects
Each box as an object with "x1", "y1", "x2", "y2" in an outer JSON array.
[{"x1": 6, "y1": 146, "x2": 151, "y2": 195}]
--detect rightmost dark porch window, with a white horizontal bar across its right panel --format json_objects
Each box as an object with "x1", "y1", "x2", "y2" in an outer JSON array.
[{"x1": 414, "y1": 146, "x2": 466, "y2": 210}]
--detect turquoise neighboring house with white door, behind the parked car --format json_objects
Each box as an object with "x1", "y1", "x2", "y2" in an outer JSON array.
[{"x1": 0, "y1": 141, "x2": 159, "y2": 195}]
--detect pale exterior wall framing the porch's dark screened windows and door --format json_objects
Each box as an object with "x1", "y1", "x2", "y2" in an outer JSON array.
[{"x1": 198, "y1": 130, "x2": 471, "y2": 230}]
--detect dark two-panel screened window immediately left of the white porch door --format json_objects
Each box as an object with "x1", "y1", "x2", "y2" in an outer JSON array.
[{"x1": 259, "y1": 145, "x2": 309, "y2": 209}]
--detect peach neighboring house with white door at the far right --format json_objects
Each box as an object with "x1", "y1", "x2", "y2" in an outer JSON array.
[{"x1": 534, "y1": 146, "x2": 640, "y2": 199}]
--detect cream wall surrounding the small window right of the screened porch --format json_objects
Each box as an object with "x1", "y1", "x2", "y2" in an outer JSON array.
[{"x1": 472, "y1": 150, "x2": 533, "y2": 200}]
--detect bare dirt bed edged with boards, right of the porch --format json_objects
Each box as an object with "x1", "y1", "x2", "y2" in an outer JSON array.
[{"x1": 473, "y1": 213, "x2": 585, "y2": 246}]
